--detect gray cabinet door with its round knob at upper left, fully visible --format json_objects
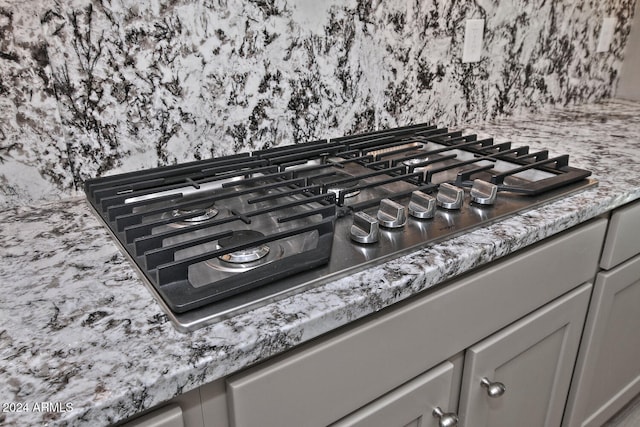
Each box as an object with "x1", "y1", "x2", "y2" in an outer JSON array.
[{"x1": 460, "y1": 284, "x2": 591, "y2": 427}]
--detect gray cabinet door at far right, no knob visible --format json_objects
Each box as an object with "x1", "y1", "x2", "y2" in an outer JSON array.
[{"x1": 564, "y1": 256, "x2": 640, "y2": 426}]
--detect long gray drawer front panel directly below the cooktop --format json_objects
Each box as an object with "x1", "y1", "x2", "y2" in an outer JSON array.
[{"x1": 227, "y1": 219, "x2": 606, "y2": 427}]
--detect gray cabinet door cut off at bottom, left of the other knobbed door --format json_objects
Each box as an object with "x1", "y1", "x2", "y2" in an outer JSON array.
[{"x1": 331, "y1": 362, "x2": 462, "y2": 427}]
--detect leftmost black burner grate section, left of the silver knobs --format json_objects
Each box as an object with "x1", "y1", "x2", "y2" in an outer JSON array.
[{"x1": 86, "y1": 157, "x2": 336, "y2": 312}]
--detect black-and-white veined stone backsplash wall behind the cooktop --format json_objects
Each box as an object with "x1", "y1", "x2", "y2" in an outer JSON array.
[{"x1": 0, "y1": 0, "x2": 635, "y2": 208}]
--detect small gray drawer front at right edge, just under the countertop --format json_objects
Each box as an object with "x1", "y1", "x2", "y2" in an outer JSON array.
[{"x1": 600, "y1": 203, "x2": 640, "y2": 270}]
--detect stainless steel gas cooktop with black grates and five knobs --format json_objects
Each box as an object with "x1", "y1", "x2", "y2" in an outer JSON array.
[{"x1": 85, "y1": 124, "x2": 596, "y2": 330}]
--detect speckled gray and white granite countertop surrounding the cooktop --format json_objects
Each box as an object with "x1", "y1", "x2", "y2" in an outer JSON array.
[{"x1": 0, "y1": 101, "x2": 640, "y2": 426}]
